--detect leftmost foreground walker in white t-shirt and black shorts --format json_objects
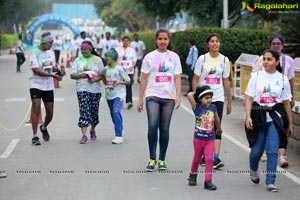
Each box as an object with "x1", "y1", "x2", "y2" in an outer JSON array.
[{"x1": 29, "y1": 32, "x2": 62, "y2": 146}]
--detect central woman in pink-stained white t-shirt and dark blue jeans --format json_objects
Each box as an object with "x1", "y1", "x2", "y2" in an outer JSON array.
[{"x1": 137, "y1": 29, "x2": 182, "y2": 171}]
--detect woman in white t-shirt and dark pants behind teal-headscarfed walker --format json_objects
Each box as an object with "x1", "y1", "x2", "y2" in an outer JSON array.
[{"x1": 116, "y1": 36, "x2": 136, "y2": 109}]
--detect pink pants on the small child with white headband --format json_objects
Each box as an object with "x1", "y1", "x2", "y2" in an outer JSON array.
[{"x1": 191, "y1": 138, "x2": 215, "y2": 181}]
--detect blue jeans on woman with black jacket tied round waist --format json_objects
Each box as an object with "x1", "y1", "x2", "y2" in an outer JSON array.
[{"x1": 249, "y1": 120, "x2": 282, "y2": 185}]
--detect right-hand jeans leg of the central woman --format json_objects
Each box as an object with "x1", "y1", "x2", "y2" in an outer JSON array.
[{"x1": 159, "y1": 99, "x2": 175, "y2": 161}]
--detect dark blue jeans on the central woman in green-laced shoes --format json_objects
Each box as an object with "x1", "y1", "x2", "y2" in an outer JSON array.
[{"x1": 146, "y1": 96, "x2": 175, "y2": 160}]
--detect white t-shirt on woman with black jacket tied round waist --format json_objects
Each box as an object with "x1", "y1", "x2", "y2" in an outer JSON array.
[{"x1": 246, "y1": 70, "x2": 292, "y2": 121}]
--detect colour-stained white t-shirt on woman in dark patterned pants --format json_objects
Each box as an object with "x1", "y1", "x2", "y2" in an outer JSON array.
[{"x1": 71, "y1": 55, "x2": 104, "y2": 93}]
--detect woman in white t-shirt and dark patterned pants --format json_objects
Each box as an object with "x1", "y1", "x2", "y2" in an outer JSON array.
[{"x1": 70, "y1": 41, "x2": 104, "y2": 144}]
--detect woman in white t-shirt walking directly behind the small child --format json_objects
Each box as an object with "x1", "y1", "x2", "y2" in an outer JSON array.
[{"x1": 192, "y1": 33, "x2": 231, "y2": 169}]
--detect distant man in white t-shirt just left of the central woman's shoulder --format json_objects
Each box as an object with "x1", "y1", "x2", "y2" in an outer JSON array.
[{"x1": 130, "y1": 33, "x2": 146, "y2": 83}]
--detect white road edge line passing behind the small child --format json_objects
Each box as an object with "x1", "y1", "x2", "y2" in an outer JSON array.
[{"x1": 180, "y1": 104, "x2": 300, "y2": 185}]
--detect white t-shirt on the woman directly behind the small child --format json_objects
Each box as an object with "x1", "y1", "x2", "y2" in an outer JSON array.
[{"x1": 194, "y1": 53, "x2": 230, "y2": 102}]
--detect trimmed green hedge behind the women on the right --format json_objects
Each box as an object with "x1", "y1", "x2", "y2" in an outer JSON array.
[{"x1": 128, "y1": 28, "x2": 272, "y2": 72}]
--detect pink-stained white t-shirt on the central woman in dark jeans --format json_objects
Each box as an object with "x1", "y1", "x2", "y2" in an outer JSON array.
[{"x1": 141, "y1": 50, "x2": 182, "y2": 99}]
